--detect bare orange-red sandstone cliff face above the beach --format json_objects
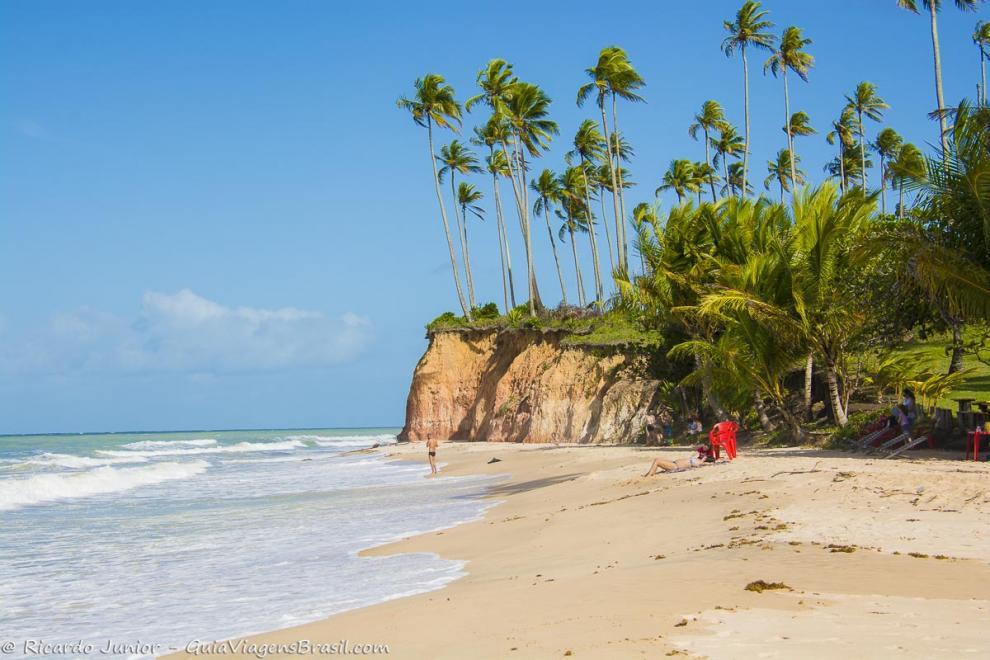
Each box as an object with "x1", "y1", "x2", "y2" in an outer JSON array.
[{"x1": 399, "y1": 331, "x2": 658, "y2": 444}]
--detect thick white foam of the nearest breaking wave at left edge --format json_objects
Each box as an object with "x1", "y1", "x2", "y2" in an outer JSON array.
[{"x1": 0, "y1": 461, "x2": 209, "y2": 510}]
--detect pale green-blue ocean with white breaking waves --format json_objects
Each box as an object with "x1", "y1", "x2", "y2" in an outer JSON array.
[{"x1": 0, "y1": 428, "x2": 492, "y2": 657}]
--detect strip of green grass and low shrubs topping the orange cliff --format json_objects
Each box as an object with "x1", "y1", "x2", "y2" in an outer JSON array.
[{"x1": 426, "y1": 303, "x2": 663, "y2": 348}]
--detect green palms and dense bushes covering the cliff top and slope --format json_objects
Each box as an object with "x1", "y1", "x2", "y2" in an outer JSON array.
[{"x1": 398, "y1": 0, "x2": 990, "y2": 444}]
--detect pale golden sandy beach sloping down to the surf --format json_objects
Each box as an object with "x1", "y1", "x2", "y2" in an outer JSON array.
[{"x1": 167, "y1": 443, "x2": 990, "y2": 658}]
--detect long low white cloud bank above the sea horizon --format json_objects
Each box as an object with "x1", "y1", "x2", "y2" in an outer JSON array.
[{"x1": 0, "y1": 289, "x2": 371, "y2": 380}]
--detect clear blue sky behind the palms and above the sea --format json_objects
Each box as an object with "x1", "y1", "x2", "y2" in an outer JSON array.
[{"x1": 0, "y1": 0, "x2": 988, "y2": 433}]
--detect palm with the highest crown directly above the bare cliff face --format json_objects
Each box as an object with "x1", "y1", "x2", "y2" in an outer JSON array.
[{"x1": 577, "y1": 46, "x2": 646, "y2": 268}]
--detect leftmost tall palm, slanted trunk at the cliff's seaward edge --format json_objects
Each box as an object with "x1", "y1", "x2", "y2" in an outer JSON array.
[{"x1": 396, "y1": 73, "x2": 471, "y2": 321}]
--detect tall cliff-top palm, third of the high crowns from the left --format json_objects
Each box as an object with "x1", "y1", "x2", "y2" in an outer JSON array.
[{"x1": 505, "y1": 82, "x2": 559, "y2": 315}]
